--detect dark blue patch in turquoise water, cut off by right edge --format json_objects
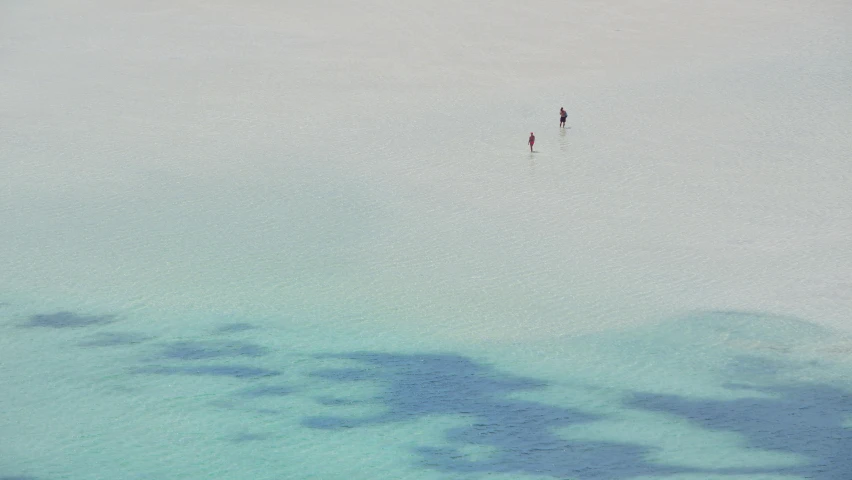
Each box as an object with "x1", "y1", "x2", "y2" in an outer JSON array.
[{"x1": 626, "y1": 359, "x2": 852, "y2": 480}]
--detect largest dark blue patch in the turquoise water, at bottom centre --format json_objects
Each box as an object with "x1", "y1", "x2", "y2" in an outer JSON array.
[{"x1": 302, "y1": 352, "x2": 675, "y2": 480}]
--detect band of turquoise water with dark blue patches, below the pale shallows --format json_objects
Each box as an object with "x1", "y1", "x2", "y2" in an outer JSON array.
[{"x1": 2, "y1": 298, "x2": 852, "y2": 479}]
